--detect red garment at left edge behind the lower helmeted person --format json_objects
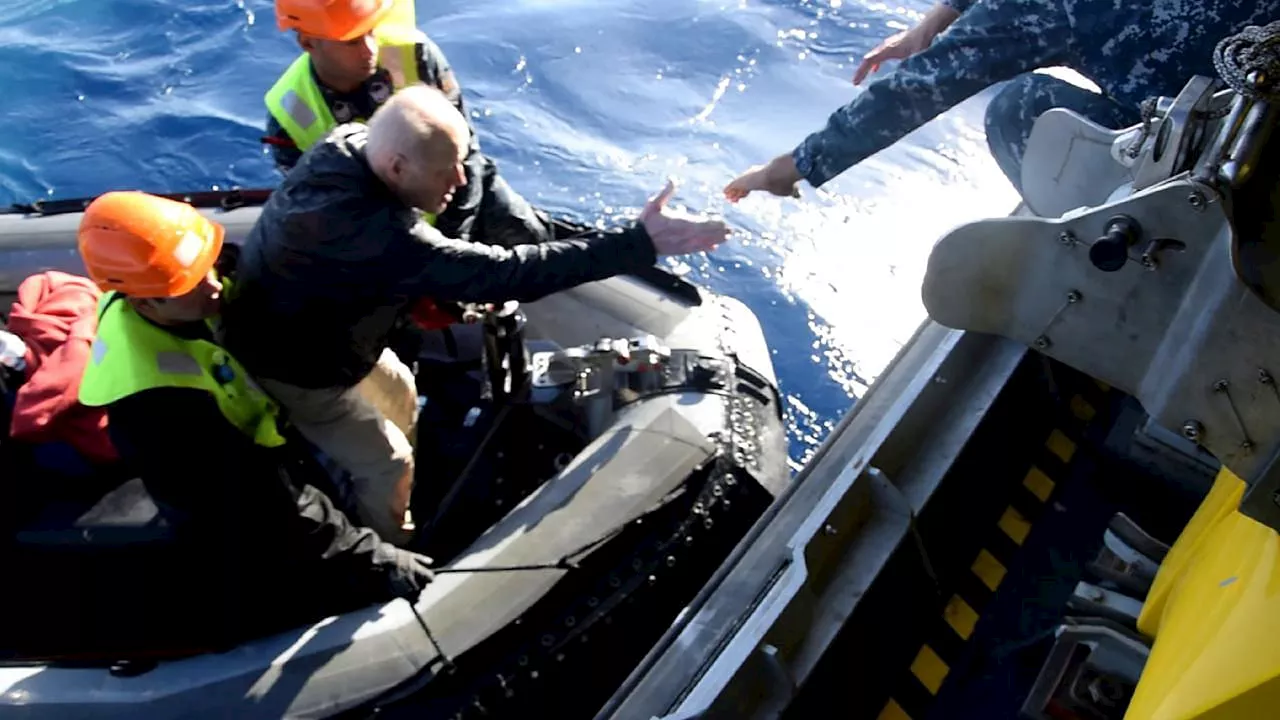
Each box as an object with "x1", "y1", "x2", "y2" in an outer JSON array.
[{"x1": 9, "y1": 270, "x2": 118, "y2": 464}]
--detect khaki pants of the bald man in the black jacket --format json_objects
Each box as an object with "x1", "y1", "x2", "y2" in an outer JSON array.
[{"x1": 259, "y1": 348, "x2": 417, "y2": 544}]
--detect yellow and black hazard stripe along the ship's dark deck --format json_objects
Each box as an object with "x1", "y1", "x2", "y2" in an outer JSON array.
[{"x1": 877, "y1": 382, "x2": 1110, "y2": 720}]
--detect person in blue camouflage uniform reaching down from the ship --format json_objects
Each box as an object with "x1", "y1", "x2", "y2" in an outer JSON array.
[{"x1": 724, "y1": 0, "x2": 1280, "y2": 202}]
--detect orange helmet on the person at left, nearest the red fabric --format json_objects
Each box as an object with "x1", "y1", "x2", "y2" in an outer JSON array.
[{"x1": 79, "y1": 191, "x2": 227, "y2": 297}]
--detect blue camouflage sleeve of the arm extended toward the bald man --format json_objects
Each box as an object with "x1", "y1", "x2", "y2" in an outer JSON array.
[{"x1": 791, "y1": 0, "x2": 1070, "y2": 187}]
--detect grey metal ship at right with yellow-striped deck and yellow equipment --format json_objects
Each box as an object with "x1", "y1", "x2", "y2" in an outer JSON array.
[{"x1": 596, "y1": 26, "x2": 1280, "y2": 720}]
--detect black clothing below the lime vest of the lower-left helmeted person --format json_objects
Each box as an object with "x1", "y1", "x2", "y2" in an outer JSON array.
[{"x1": 108, "y1": 335, "x2": 428, "y2": 639}]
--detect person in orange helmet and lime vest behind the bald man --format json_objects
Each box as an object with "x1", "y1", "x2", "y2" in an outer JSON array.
[{"x1": 262, "y1": 0, "x2": 552, "y2": 247}]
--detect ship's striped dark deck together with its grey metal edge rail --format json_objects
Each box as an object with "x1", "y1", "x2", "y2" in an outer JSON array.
[{"x1": 596, "y1": 322, "x2": 1215, "y2": 720}]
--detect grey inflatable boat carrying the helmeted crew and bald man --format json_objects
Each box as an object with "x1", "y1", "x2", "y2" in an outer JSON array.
[{"x1": 0, "y1": 190, "x2": 790, "y2": 720}]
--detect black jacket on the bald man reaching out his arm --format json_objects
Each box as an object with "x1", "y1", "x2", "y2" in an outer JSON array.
[{"x1": 223, "y1": 123, "x2": 655, "y2": 388}]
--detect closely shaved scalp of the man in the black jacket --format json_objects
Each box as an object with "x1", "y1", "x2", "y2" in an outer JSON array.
[{"x1": 365, "y1": 83, "x2": 470, "y2": 165}]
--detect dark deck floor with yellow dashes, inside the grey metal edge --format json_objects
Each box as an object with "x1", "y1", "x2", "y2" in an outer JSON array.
[{"x1": 783, "y1": 355, "x2": 1207, "y2": 720}]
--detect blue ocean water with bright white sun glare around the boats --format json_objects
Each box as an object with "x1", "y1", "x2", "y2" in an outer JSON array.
[{"x1": 0, "y1": 0, "x2": 1016, "y2": 466}]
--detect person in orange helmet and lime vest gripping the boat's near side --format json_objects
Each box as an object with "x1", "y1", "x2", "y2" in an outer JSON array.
[{"x1": 78, "y1": 191, "x2": 433, "y2": 641}]
